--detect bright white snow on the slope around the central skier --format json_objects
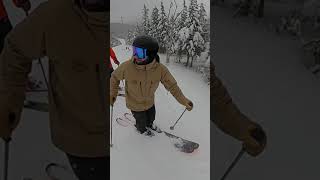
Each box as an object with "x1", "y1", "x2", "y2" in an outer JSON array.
[{"x1": 111, "y1": 41, "x2": 210, "y2": 180}]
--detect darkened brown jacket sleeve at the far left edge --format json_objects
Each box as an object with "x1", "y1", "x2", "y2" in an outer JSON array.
[{"x1": 0, "y1": 5, "x2": 45, "y2": 131}]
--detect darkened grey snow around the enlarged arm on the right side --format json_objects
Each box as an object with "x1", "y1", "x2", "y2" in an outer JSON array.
[{"x1": 211, "y1": 7, "x2": 320, "y2": 180}]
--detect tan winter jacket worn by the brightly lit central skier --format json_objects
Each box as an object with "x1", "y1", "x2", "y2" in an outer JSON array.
[{"x1": 110, "y1": 59, "x2": 189, "y2": 111}]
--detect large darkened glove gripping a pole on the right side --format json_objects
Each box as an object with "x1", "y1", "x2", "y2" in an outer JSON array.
[{"x1": 243, "y1": 123, "x2": 267, "y2": 156}]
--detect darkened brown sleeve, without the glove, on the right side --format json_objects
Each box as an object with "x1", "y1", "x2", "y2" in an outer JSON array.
[{"x1": 210, "y1": 64, "x2": 253, "y2": 141}]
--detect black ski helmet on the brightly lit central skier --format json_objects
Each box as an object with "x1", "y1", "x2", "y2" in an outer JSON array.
[{"x1": 132, "y1": 35, "x2": 159, "y2": 64}]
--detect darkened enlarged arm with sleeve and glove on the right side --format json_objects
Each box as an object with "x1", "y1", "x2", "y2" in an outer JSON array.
[{"x1": 210, "y1": 64, "x2": 267, "y2": 156}]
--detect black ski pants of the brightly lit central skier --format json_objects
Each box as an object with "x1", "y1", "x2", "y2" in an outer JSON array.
[{"x1": 131, "y1": 105, "x2": 156, "y2": 133}]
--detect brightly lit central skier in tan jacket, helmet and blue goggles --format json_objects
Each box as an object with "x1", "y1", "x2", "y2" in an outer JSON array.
[{"x1": 110, "y1": 35, "x2": 193, "y2": 136}]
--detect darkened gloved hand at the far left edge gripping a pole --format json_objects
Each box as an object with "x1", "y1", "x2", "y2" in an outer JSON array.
[{"x1": 0, "y1": 109, "x2": 17, "y2": 139}]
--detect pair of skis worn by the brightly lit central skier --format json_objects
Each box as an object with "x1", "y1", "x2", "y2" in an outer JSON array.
[{"x1": 116, "y1": 113, "x2": 200, "y2": 154}]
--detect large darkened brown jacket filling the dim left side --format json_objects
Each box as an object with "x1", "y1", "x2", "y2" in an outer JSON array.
[{"x1": 0, "y1": 0, "x2": 110, "y2": 157}]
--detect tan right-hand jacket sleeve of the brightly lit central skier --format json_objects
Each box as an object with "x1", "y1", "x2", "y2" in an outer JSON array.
[{"x1": 160, "y1": 64, "x2": 188, "y2": 106}]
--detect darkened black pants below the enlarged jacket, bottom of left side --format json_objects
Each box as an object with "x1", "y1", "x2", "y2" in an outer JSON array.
[{"x1": 67, "y1": 154, "x2": 110, "y2": 180}]
